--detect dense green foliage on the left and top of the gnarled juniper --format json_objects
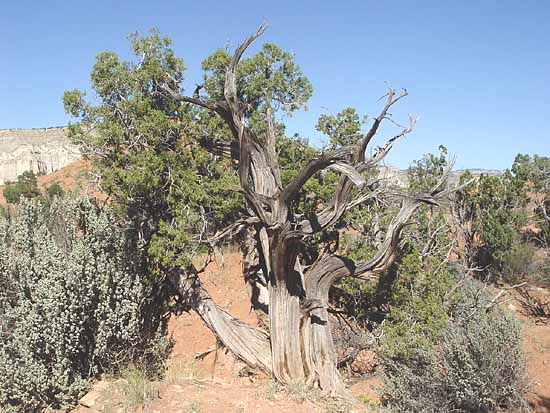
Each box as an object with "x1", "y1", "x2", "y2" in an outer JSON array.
[{"x1": 63, "y1": 30, "x2": 320, "y2": 271}]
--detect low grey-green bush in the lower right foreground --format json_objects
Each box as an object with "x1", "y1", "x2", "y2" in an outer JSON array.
[{"x1": 381, "y1": 284, "x2": 528, "y2": 413}]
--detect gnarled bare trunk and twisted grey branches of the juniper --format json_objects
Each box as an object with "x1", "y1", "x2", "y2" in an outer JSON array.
[{"x1": 172, "y1": 26, "x2": 462, "y2": 396}]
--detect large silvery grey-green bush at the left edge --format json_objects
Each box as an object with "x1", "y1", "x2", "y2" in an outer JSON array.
[{"x1": 0, "y1": 198, "x2": 169, "y2": 412}]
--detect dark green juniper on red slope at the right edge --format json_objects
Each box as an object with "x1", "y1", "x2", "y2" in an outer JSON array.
[{"x1": 457, "y1": 154, "x2": 550, "y2": 282}]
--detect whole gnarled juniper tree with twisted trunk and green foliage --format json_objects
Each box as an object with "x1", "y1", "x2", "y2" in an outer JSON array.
[{"x1": 65, "y1": 25, "x2": 460, "y2": 395}]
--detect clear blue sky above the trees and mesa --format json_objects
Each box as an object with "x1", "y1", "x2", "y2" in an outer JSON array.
[{"x1": 0, "y1": 0, "x2": 550, "y2": 169}]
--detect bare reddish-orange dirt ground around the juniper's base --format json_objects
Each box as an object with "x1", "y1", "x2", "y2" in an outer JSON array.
[{"x1": 67, "y1": 253, "x2": 550, "y2": 413}]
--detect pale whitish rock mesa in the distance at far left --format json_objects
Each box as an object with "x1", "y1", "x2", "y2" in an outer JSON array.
[{"x1": 0, "y1": 127, "x2": 82, "y2": 185}]
